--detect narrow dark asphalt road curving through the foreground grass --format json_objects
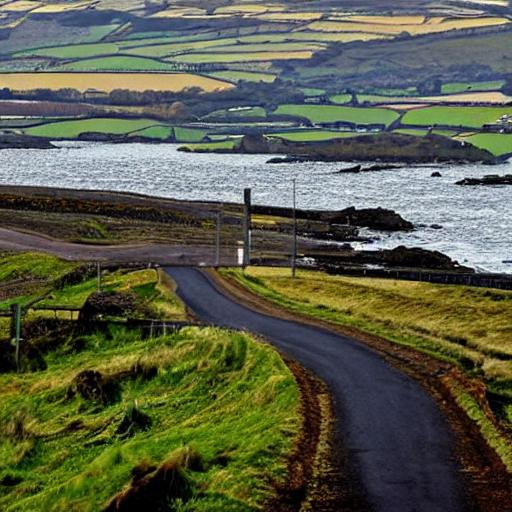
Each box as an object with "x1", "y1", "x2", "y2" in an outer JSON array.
[{"x1": 167, "y1": 267, "x2": 468, "y2": 512}]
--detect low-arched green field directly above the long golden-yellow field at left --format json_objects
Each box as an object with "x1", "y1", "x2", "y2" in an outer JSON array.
[{"x1": 56, "y1": 55, "x2": 179, "y2": 71}]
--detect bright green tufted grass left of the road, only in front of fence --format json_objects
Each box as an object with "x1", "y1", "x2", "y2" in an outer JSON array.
[{"x1": 0, "y1": 328, "x2": 300, "y2": 512}]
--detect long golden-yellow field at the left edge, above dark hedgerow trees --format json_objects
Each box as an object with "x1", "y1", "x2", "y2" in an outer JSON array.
[{"x1": 0, "y1": 73, "x2": 234, "y2": 92}]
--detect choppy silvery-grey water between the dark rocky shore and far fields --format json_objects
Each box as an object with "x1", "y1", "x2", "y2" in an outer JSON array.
[{"x1": 0, "y1": 142, "x2": 512, "y2": 273}]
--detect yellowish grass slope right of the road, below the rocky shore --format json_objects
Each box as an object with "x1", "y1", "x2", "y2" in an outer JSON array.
[{"x1": 226, "y1": 268, "x2": 512, "y2": 382}]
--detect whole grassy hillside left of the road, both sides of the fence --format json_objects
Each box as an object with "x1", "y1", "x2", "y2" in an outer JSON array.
[{"x1": 0, "y1": 253, "x2": 301, "y2": 512}]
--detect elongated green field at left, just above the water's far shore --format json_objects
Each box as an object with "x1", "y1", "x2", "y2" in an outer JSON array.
[{"x1": 25, "y1": 118, "x2": 157, "y2": 139}]
